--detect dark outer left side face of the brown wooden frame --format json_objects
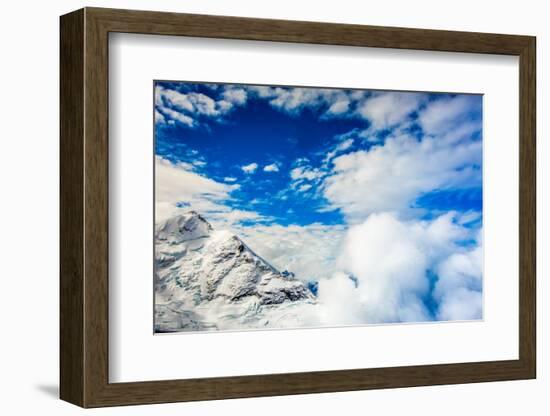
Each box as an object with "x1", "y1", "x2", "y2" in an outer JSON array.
[{"x1": 59, "y1": 10, "x2": 85, "y2": 406}]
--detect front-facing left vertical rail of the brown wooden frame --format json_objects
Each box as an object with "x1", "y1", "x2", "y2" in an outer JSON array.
[{"x1": 84, "y1": 11, "x2": 109, "y2": 406}]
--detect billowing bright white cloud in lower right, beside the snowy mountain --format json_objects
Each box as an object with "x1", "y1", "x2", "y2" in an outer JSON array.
[{"x1": 319, "y1": 213, "x2": 481, "y2": 324}]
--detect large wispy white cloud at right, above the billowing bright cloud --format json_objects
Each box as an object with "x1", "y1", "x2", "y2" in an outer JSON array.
[{"x1": 323, "y1": 129, "x2": 482, "y2": 221}]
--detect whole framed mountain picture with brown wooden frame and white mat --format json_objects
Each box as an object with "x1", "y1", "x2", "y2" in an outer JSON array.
[{"x1": 60, "y1": 8, "x2": 536, "y2": 407}]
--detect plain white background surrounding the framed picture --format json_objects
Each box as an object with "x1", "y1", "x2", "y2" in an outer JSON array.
[{"x1": 0, "y1": 0, "x2": 550, "y2": 416}]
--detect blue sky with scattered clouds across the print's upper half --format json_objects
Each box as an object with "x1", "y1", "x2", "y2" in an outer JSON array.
[{"x1": 155, "y1": 81, "x2": 482, "y2": 229}]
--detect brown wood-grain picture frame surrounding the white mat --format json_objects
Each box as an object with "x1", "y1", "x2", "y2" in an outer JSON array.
[{"x1": 60, "y1": 8, "x2": 536, "y2": 407}]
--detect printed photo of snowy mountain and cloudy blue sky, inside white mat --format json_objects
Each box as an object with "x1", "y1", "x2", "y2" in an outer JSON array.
[{"x1": 154, "y1": 81, "x2": 483, "y2": 333}]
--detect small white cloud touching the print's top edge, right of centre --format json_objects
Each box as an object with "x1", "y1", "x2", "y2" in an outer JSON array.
[{"x1": 357, "y1": 92, "x2": 426, "y2": 130}]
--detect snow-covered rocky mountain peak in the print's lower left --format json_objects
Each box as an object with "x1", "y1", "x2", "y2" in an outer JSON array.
[{"x1": 155, "y1": 211, "x2": 316, "y2": 332}]
